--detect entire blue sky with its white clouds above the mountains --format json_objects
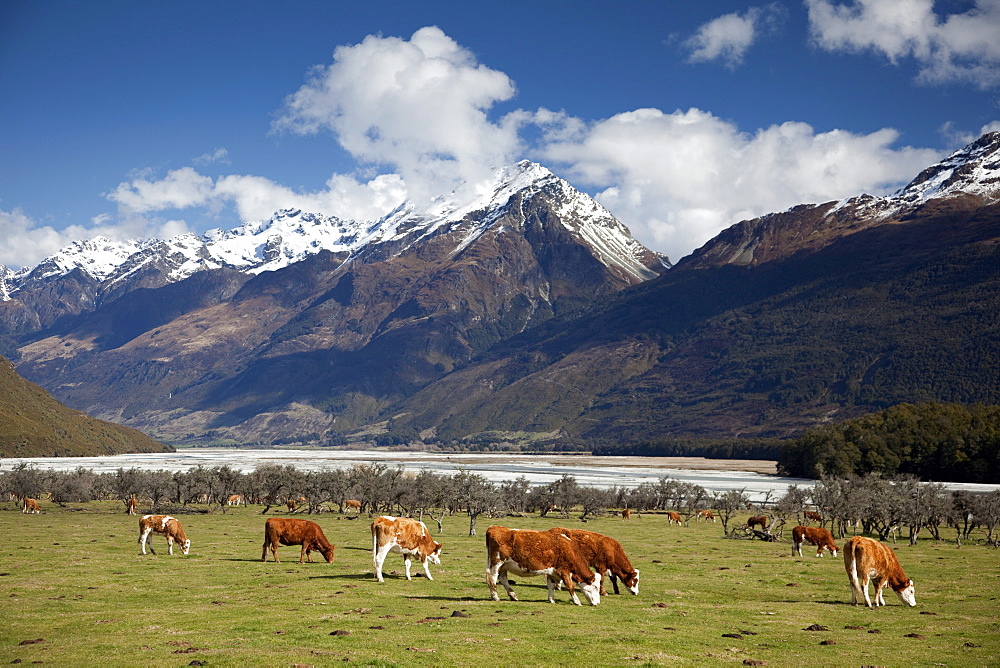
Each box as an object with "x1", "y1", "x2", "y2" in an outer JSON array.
[{"x1": 0, "y1": 0, "x2": 1000, "y2": 268}]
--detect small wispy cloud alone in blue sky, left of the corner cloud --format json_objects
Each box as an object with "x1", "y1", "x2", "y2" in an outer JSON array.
[{"x1": 683, "y1": 3, "x2": 784, "y2": 69}]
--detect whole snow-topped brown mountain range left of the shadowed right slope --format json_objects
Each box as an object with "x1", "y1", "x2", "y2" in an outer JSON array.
[{"x1": 7, "y1": 162, "x2": 668, "y2": 442}]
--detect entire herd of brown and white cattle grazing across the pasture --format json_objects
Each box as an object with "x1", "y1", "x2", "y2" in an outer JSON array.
[{"x1": 22, "y1": 498, "x2": 917, "y2": 608}]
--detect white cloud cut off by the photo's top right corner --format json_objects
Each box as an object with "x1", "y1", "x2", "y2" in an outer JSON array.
[{"x1": 805, "y1": 0, "x2": 1000, "y2": 90}]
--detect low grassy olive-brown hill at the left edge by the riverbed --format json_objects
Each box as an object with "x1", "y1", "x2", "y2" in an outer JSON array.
[{"x1": 0, "y1": 357, "x2": 173, "y2": 457}]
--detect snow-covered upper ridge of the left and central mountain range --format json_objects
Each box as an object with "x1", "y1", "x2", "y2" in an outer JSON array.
[{"x1": 0, "y1": 161, "x2": 656, "y2": 299}]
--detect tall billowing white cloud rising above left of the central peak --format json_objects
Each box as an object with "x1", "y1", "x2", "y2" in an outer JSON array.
[{"x1": 273, "y1": 27, "x2": 519, "y2": 200}]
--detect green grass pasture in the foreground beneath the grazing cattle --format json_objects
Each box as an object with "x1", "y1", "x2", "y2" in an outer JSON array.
[{"x1": 0, "y1": 501, "x2": 1000, "y2": 666}]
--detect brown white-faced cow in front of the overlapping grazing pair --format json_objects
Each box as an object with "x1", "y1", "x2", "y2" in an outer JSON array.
[{"x1": 486, "y1": 526, "x2": 601, "y2": 605}]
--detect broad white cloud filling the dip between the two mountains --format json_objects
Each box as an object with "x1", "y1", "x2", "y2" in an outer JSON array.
[{"x1": 543, "y1": 109, "x2": 940, "y2": 260}]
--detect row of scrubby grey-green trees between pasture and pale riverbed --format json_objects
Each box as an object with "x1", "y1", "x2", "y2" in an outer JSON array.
[{"x1": 0, "y1": 463, "x2": 1000, "y2": 545}]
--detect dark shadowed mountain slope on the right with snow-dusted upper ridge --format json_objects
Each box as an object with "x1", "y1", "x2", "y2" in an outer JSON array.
[{"x1": 397, "y1": 134, "x2": 1000, "y2": 440}]
